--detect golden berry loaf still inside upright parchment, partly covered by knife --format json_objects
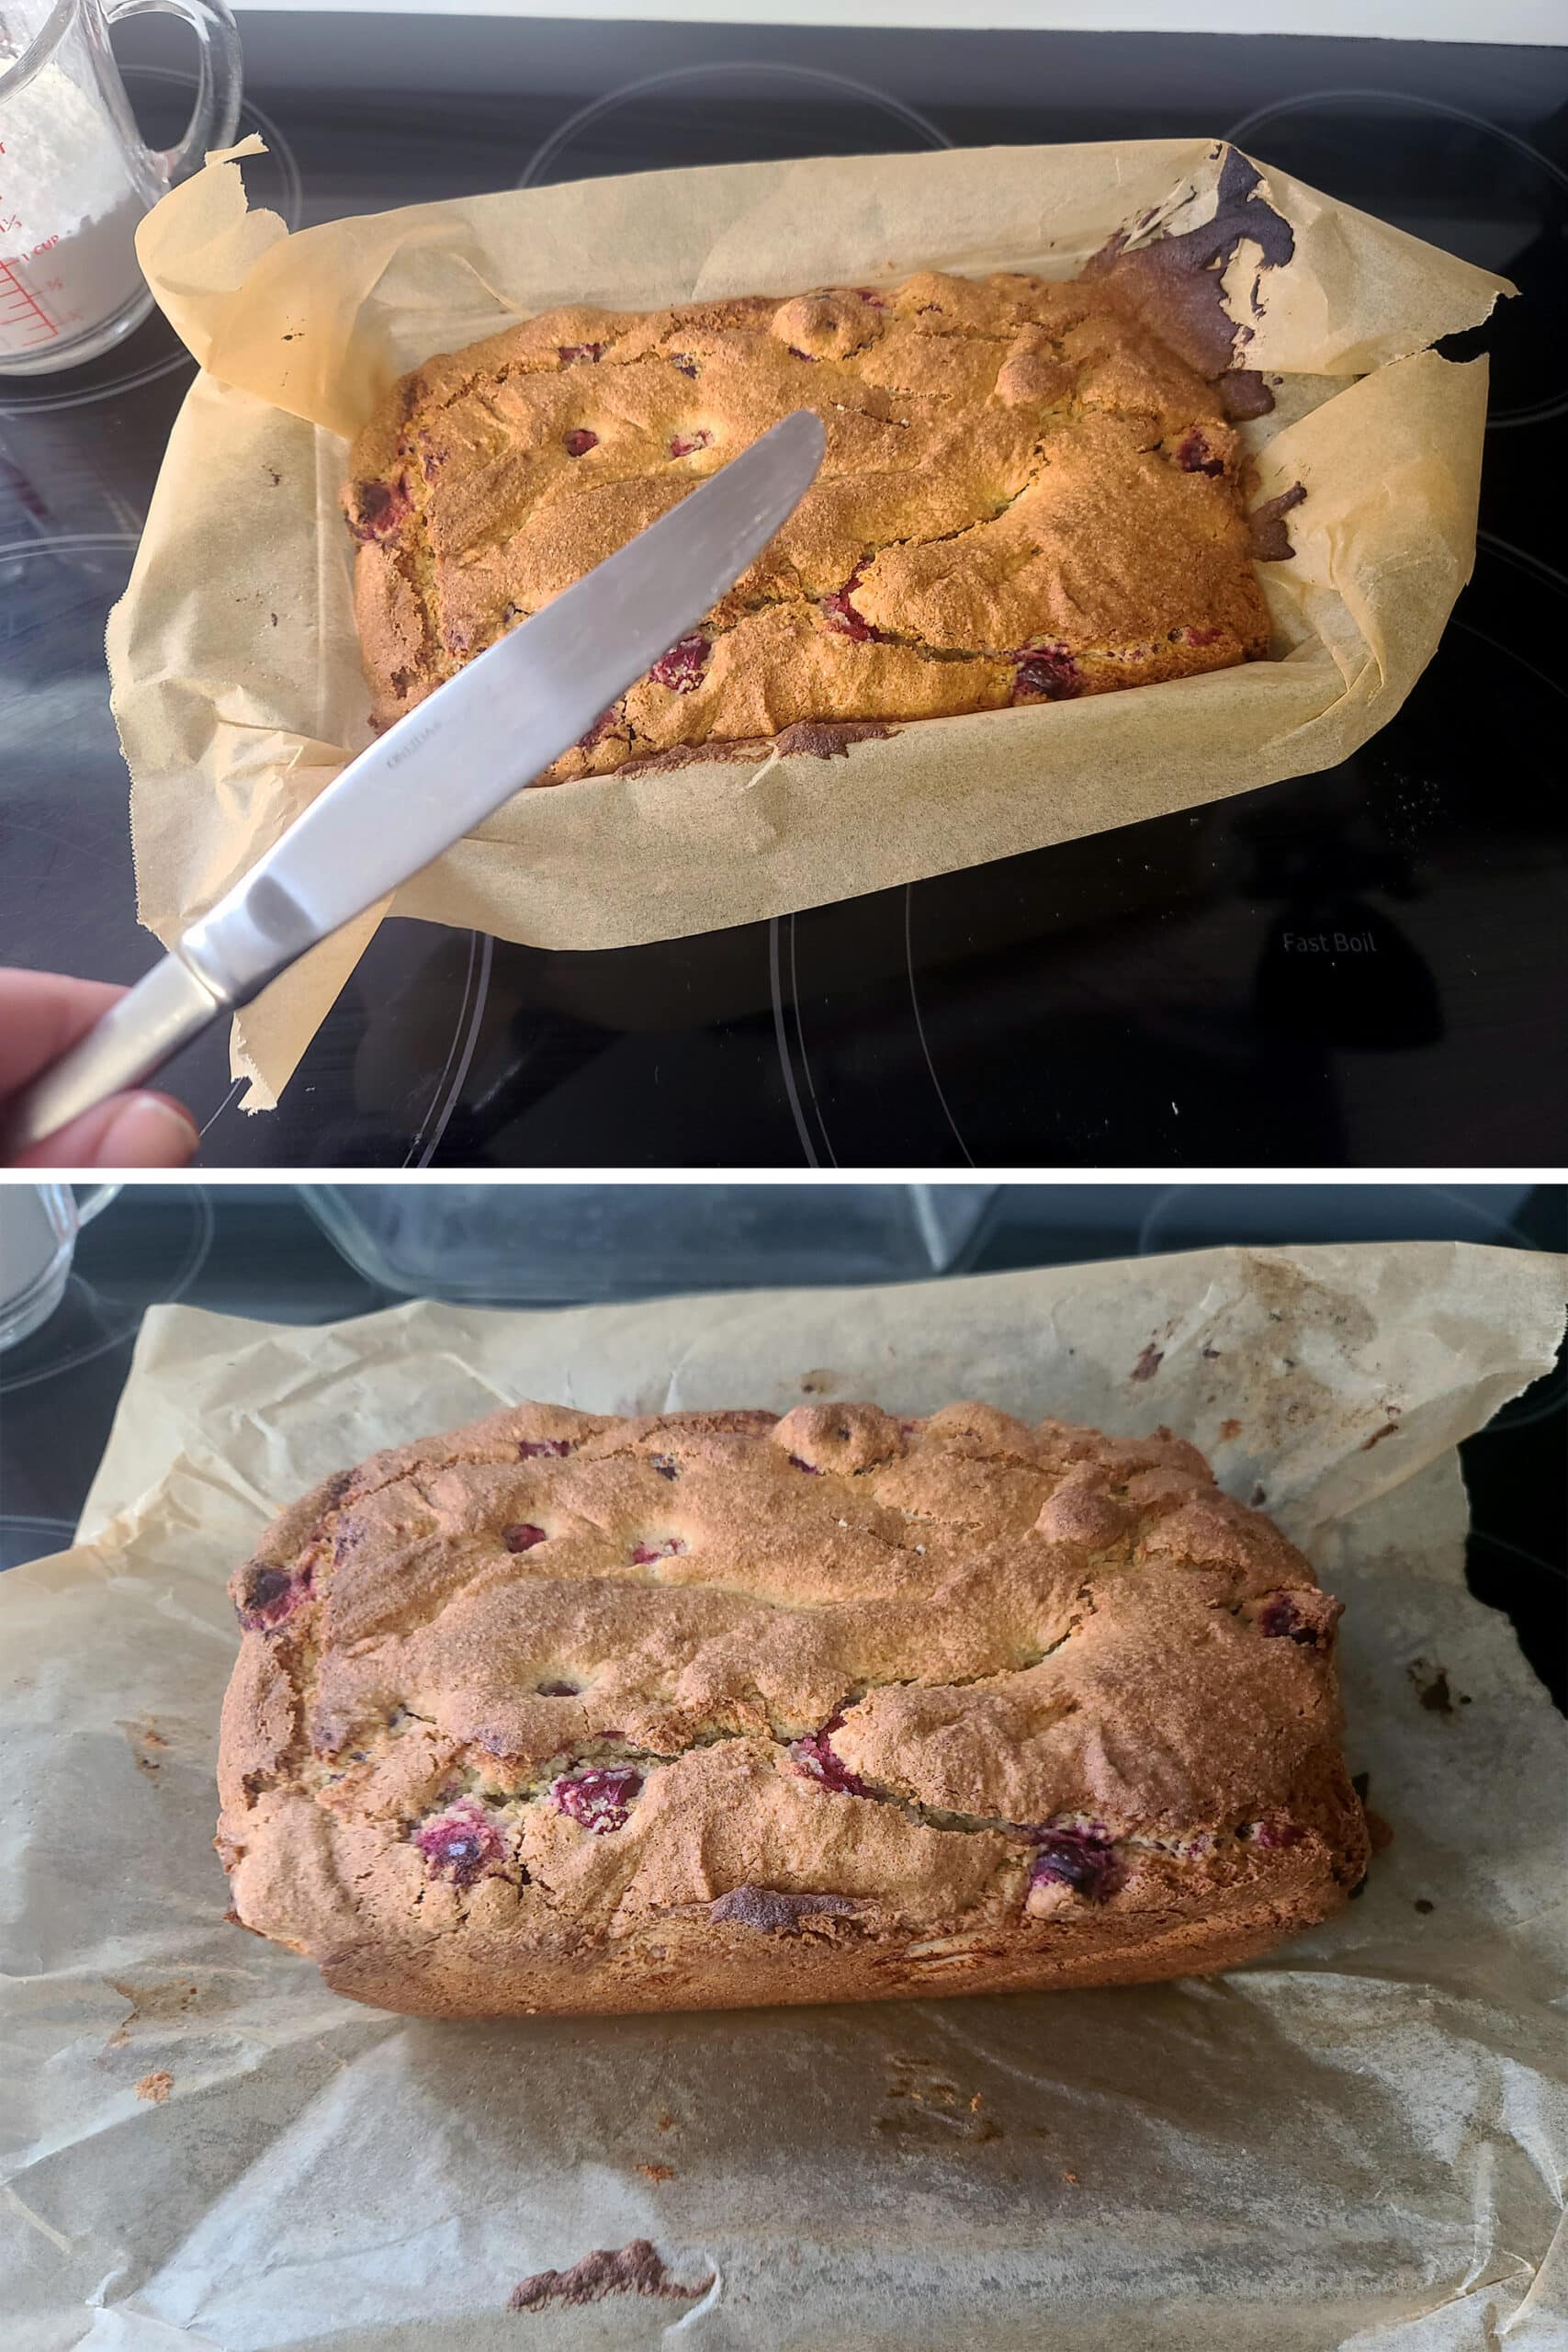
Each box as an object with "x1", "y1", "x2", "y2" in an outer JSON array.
[{"x1": 344, "y1": 266, "x2": 1291, "y2": 781}]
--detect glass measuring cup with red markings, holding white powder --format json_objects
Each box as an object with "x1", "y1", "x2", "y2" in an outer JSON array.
[{"x1": 0, "y1": 0, "x2": 240, "y2": 377}]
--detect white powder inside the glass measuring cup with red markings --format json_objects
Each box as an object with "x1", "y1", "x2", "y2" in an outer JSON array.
[{"x1": 0, "y1": 59, "x2": 163, "y2": 356}]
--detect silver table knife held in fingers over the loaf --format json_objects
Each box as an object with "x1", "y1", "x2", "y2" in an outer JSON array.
[{"x1": 5, "y1": 409, "x2": 825, "y2": 1155}]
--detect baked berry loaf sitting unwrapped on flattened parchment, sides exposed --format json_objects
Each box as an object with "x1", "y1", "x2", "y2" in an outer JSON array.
[{"x1": 219, "y1": 1404, "x2": 1366, "y2": 2016}]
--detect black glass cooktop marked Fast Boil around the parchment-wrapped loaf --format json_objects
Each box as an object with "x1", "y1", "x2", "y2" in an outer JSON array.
[{"x1": 0, "y1": 28, "x2": 1568, "y2": 1167}]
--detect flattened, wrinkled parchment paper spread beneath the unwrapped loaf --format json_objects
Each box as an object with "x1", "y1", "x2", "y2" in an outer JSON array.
[{"x1": 0, "y1": 1242, "x2": 1568, "y2": 2352}]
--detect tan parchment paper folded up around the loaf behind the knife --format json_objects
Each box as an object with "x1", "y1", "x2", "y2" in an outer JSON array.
[{"x1": 108, "y1": 139, "x2": 1512, "y2": 1108}]
